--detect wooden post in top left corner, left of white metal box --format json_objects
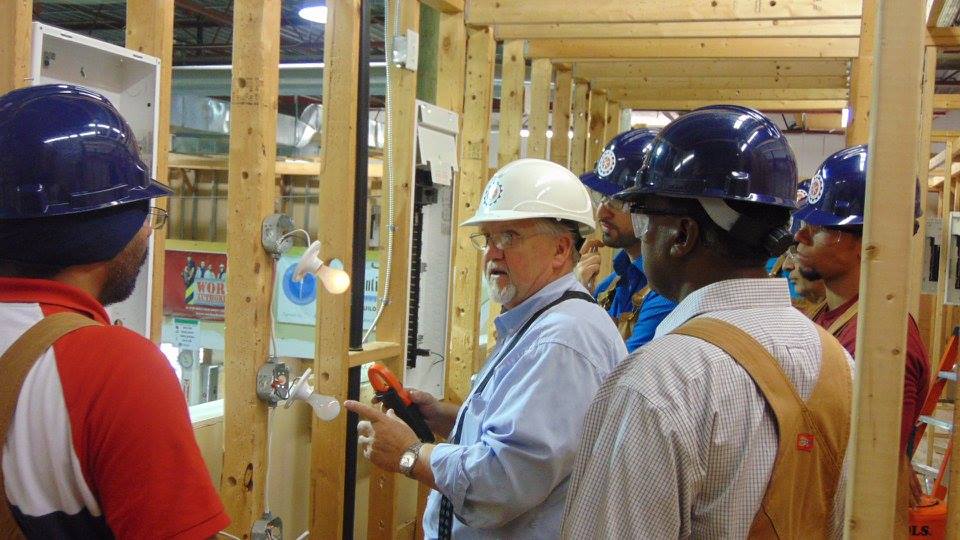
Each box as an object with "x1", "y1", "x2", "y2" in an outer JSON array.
[{"x1": 0, "y1": 0, "x2": 33, "y2": 95}]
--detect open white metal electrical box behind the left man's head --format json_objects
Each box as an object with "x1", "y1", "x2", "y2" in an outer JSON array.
[{"x1": 30, "y1": 23, "x2": 160, "y2": 337}]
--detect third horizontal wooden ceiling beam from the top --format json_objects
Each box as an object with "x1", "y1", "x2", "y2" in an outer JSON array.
[{"x1": 527, "y1": 38, "x2": 860, "y2": 61}]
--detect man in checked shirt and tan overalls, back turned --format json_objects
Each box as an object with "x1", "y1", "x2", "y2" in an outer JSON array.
[{"x1": 563, "y1": 105, "x2": 852, "y2": 538}]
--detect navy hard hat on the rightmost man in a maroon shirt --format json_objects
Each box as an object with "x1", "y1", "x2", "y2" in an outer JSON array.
[{"x1": 793, "y1": 145, "x2": 922, "y2": 227}]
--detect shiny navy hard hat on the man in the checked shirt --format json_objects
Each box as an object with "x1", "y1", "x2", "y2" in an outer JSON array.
[{"x1": 617, "y1": 105, "x2": 797, "y2": 208}]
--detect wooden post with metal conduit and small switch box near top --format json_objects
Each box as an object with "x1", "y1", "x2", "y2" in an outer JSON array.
[{"x1": 367, "y1": 0, "x2": 420, "y2": 538}]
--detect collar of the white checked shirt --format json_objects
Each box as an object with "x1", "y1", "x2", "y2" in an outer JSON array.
[{"x1": 654, "y1": 278, "x2": 792, "y2": 338}]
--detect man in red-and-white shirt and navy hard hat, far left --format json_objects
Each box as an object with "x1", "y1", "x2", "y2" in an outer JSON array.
[{"x1": 0, "y1": 85, "x2": 230, "y2": 539}]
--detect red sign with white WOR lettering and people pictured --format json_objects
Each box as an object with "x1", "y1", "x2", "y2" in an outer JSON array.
[{"x1": 163, "y1": 249, "x2": 227, "y2": 321}]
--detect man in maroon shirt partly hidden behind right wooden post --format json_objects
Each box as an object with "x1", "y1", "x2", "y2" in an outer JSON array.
[{"x1": 793, "y1": 145, "x2": 930, "y2": 455}]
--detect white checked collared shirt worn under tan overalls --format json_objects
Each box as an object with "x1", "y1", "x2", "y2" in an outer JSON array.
[{"x1": 563, "y1": 279, "x2": 853, "y2": 539}]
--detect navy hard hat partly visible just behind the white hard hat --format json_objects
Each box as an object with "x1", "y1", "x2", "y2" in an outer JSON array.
[{"x1": 580, "y1": 129, "x2": 657, "y2": 197}]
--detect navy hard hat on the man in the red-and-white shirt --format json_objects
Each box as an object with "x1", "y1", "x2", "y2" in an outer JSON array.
[{"x1": 0, "y1": 84, "x2": 172, "y2": 220}]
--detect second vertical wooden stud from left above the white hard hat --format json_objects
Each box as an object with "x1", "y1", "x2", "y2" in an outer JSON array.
[{"x1": 497, "y1": 40, "x2": 527, "y2": 167}]
